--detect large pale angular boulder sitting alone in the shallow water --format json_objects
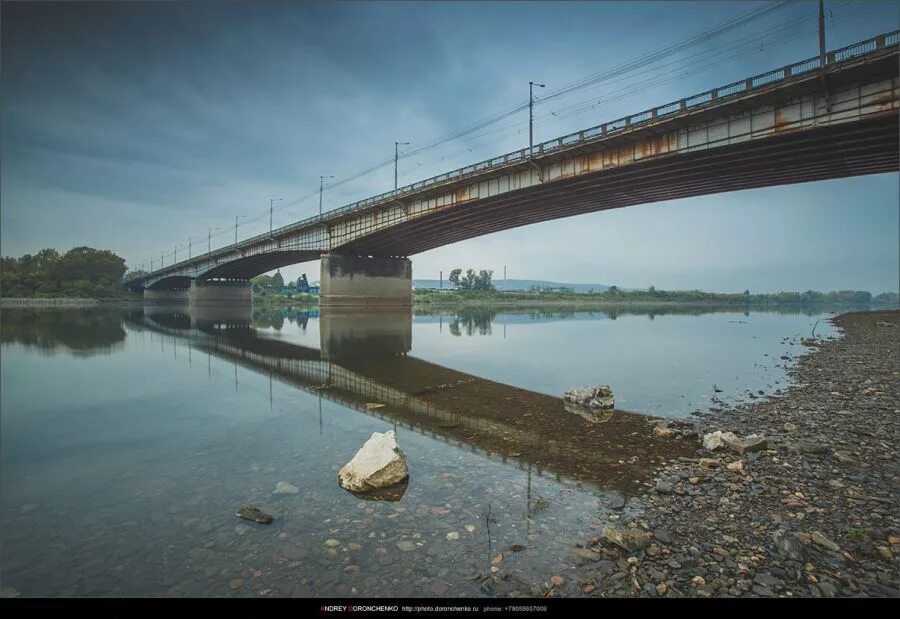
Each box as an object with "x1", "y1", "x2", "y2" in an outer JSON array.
[{"x1": 338, "y1": 430, "x2": 409, "y2": 492}]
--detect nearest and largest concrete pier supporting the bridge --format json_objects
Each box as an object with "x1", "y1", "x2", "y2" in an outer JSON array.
[{"x1": 319, "y1": 254, "x2": 412, "y2": 307}]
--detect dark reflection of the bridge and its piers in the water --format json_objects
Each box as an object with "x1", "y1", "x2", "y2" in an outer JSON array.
[{"x1": 131, "y1": 307, "x2": 690, "y2": 491}]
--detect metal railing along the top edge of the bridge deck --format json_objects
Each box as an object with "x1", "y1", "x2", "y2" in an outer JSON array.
[{"x1": 137, "y1": 30, "x2": 900, "y2": 280}]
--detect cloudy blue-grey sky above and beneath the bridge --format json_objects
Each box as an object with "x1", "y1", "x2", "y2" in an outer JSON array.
[{"x1": 0, "y1": 0, "x2": 900, "y2": 292}]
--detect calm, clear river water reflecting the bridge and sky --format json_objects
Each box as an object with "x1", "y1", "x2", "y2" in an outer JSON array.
[{"x1": 0, "y1": 307, "x2": 833, "y2": 596}]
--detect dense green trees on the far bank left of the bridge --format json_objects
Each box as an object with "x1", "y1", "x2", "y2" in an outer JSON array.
[{"x1": 0, "y1": 247, "x2": 126, "y2": 299}]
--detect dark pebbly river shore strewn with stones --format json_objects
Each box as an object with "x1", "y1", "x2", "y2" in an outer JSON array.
[{"x1": 572, "y1": 311, "x2": 900, "y2": 597}]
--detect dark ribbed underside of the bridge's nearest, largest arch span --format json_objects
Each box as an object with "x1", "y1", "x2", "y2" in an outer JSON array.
[{"x1": 334, "y1": 112, "x2": 900, "y2": 256}]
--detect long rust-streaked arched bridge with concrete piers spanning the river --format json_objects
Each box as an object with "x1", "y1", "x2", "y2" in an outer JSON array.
[{"x1": 125, "y1": 31, "x2": 900, "y2": 307}]
